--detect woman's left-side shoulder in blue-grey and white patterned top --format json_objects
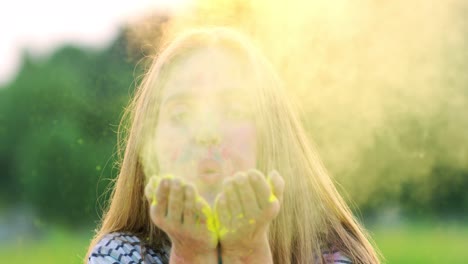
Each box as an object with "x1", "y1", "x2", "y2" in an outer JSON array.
[{"x1": 88, "y1": 232, "x2": 167, "y2": 264}]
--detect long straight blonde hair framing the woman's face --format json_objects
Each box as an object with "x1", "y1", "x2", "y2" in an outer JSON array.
[{"x1": 85, "y1": 28, "x2": 380, "y2": 263}]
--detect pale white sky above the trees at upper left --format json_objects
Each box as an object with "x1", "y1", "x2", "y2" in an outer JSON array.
[{"x1": 0, "y1": 0, "x2": 188, "y2": 85}]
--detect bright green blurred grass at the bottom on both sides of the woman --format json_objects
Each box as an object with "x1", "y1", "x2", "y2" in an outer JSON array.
[{"x1": 0, "y1": 223, "x2": 468, "y2": 264}]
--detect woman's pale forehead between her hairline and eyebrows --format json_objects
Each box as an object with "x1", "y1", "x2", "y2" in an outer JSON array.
[{"x1": 162, "y1": 47, "x2": 255, "y2": 101}]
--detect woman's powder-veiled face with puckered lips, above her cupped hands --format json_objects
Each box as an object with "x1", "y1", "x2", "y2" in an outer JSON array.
[{"x1": 156, "y1": 48, "x2": 257, "y2": 203}]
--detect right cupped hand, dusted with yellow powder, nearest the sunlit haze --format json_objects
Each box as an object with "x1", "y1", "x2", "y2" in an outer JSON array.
[{"x1": 215, "y1": 170, "x2": 284, "y2": 263}]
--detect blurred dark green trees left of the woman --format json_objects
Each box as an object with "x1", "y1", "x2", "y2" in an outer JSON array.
[{"x1": 0, "y1": 33, "x2": 134, "y2": 227}]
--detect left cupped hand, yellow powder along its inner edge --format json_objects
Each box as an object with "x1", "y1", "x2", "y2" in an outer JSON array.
[{"x1": 145, "y1": 176, "x2": 218, "y2": 263}]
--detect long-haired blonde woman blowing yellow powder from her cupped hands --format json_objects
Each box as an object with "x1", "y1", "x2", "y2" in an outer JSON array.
[{"x1": 85, "y1": 25, "x2": 379, "y2": 263}]
